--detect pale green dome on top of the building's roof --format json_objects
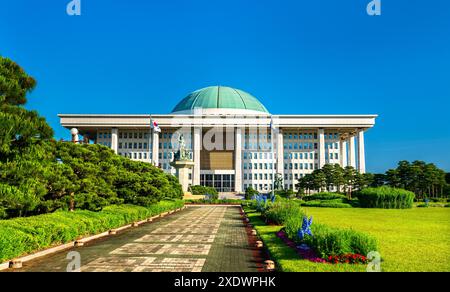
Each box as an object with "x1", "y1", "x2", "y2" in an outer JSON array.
[{"x1": 172, "y1": 86, "x2": 268, "y2": 113}]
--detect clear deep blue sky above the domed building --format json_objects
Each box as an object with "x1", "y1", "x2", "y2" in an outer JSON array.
[{"x1": 0, "y1": 0, "x2": 450, "y2": 172}]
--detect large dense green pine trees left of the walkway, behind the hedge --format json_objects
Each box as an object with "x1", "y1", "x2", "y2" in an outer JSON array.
[{"x1": 0, "y1": 56, "x2": 182, "y2": 219}]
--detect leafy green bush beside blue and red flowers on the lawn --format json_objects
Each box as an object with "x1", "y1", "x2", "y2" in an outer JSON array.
[{"x1": 285, "y1": 222, "x2": 377, "y2": 259}]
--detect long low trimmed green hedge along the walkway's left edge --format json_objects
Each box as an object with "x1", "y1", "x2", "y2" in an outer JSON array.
[{"x1": 0, "y1": 200, "x2": 184, "y2": 263}]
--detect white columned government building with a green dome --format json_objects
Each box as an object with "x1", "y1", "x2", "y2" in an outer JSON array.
[{"x1": 59, "y1": 86, "x2": 377, "y2": 193}]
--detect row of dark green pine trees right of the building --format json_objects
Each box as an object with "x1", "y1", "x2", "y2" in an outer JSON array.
[{"x1": 296, "y1": 161, "x2": 450, "y2": 199}]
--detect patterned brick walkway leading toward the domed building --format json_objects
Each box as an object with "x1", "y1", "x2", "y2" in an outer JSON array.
[{"x1": 17, "y1": 206, "x2": 257, "y2": 272}]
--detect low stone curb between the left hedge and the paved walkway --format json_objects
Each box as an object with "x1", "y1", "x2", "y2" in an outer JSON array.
[{"x1": 0, "y1": 205, "x2": 187, "y2": 271}]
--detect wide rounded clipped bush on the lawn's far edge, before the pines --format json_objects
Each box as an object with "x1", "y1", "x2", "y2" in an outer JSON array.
[{"x1": 357, "y1": 186, "x2": 415, "y2": 209}]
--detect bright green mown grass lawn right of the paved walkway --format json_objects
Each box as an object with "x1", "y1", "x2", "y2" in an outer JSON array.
[{"x1": 247, "y1": 208, "x2": 450, "y2": 272}]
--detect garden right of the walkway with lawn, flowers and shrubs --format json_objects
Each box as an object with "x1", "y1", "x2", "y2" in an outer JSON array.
[{"x1": 244, "y1": 187, "x2": 450, "y2": 272}]
